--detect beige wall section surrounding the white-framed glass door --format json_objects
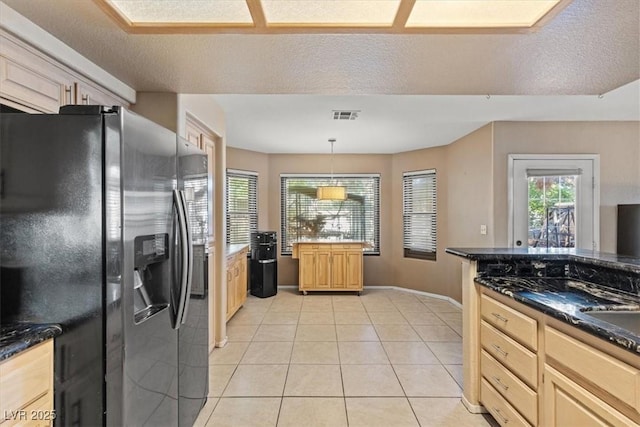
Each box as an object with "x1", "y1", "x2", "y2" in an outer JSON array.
[{"x1": 493, "y1": 122, "x2": 640, "y2": 252}]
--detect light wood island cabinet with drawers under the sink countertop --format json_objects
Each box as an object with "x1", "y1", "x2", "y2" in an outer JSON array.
[{"x1": 477, "y1": 289, "x2": 640, "y2": 427}]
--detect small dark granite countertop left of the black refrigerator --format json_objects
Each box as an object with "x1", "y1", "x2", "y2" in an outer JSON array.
[{"x1": 0, "y1": 323, "x2": 62, "y2": 360}]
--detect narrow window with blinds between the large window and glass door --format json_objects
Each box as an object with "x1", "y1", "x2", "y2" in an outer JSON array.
[{"x1": 402, "y1": 169, "x2": 438, "y2": 261}]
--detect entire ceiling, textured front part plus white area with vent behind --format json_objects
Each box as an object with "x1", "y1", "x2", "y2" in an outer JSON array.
[{"x1": 0, "y1": 0, "x2": 640, "y2": 153}]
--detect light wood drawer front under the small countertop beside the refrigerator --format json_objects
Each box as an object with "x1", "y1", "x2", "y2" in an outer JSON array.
[{"x1": 0, "y1": 340, "x2": 53, "y2": 422}]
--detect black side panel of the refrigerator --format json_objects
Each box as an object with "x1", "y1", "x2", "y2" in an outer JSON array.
[{"x1": 0, "y1": 113, "x2": 104, "y2": 426}]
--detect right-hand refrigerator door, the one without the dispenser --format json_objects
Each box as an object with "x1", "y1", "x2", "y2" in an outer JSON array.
[{"x1": 178, "y1": 137, "x2": 209, "y2": 427}]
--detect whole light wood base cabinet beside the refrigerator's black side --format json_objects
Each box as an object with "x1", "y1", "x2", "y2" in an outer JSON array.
[{"x1": 0, "y1": 339, "x2": 55, "y2": 427}]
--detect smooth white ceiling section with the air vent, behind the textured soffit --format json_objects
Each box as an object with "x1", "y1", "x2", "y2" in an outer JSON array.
[{"x1": 214, "y1": 80, "x2": 640, "y2": 153}]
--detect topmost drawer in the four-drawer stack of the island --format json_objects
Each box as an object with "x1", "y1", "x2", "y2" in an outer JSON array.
[{"x1": 480, "y1": 295, "x2": 538, "y2": 351}]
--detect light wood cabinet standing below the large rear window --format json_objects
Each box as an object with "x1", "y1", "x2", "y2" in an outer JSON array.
[{"x1": 293, "y1": 243, "x2": 363, "y2": 293}]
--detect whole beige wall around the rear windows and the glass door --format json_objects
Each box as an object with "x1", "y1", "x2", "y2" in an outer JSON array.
[{"x1": 227, "y1": 122, "x2": 640, "y2": 301}]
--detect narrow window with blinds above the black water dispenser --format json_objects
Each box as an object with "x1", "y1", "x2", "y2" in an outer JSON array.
[{"x1": 227, "y1": 169, "x2": 258, "y2": 244}]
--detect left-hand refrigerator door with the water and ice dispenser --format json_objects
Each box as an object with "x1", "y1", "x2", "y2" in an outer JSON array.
[{"x1": 114, "y1": 110, "x2": 180, "y2": 426}]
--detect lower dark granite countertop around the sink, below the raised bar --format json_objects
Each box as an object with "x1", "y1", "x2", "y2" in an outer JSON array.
[{"x1": 476, "y1": 276, "x2": 640, "y2": 354}]
